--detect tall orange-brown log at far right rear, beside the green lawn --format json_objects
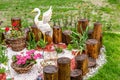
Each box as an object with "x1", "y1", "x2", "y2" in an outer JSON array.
[{"x1": 93, "y1": 22, "x2": 102, "y2": 41}]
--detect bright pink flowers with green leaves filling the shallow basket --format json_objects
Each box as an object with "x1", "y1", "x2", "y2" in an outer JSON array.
[{"x1": 12, "y1": 50, "x2": 42, "y2": 67}]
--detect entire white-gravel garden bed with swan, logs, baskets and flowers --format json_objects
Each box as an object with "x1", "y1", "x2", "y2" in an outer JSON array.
[{"x1": 0, "y1": 7, "x2": 106, "y2": 80}]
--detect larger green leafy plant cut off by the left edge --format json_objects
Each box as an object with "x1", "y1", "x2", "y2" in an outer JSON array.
[{"x1": 0, "y1": 45, "x2": 8, "y2": 64}]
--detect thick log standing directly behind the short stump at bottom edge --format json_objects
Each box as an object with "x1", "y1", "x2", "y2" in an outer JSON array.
[{"x1": 75, "y1": 54, "x2": 89, "y2": 75}]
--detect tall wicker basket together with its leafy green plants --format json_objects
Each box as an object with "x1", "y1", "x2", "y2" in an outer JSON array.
[{"x1": 5, "y1": 27, "x2": 26, "y2": 51}]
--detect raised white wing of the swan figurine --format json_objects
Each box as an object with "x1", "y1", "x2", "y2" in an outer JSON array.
[{"x1": 42, "y1": 6, "x2": 52, "y2": 23}]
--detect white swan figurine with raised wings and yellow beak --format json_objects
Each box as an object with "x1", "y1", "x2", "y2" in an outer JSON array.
[{"x1": 32, "y1": 6, "x2": 53, "y2": 38}]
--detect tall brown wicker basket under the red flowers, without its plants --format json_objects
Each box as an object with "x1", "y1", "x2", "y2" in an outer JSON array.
[{"x1": 6, "y1": 37, "x2": 26, "y2": 51}]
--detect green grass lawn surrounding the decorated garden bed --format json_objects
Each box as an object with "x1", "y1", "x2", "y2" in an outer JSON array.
[{"x1": 0, "y1": 0, "x2": 120, "y2": 80}]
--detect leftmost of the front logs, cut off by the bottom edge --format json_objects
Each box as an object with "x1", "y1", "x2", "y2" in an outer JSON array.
[{"x1": 43, "y1": 65, "x2": 58, "y2": 80}]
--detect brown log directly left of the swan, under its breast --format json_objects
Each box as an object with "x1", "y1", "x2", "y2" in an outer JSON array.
[{"x1": 31, "y1": 25, "x2": 42, "y2": 41}]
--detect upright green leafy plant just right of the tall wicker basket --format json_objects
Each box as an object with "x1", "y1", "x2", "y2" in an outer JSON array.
[{"x1": 27, "y1": 32, "x2": 37, "y2": 50}]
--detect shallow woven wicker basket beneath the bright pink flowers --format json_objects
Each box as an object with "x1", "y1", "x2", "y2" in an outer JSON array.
[{"x1": 11, "y1": 62, "x2": 34, "y2": 74}]
